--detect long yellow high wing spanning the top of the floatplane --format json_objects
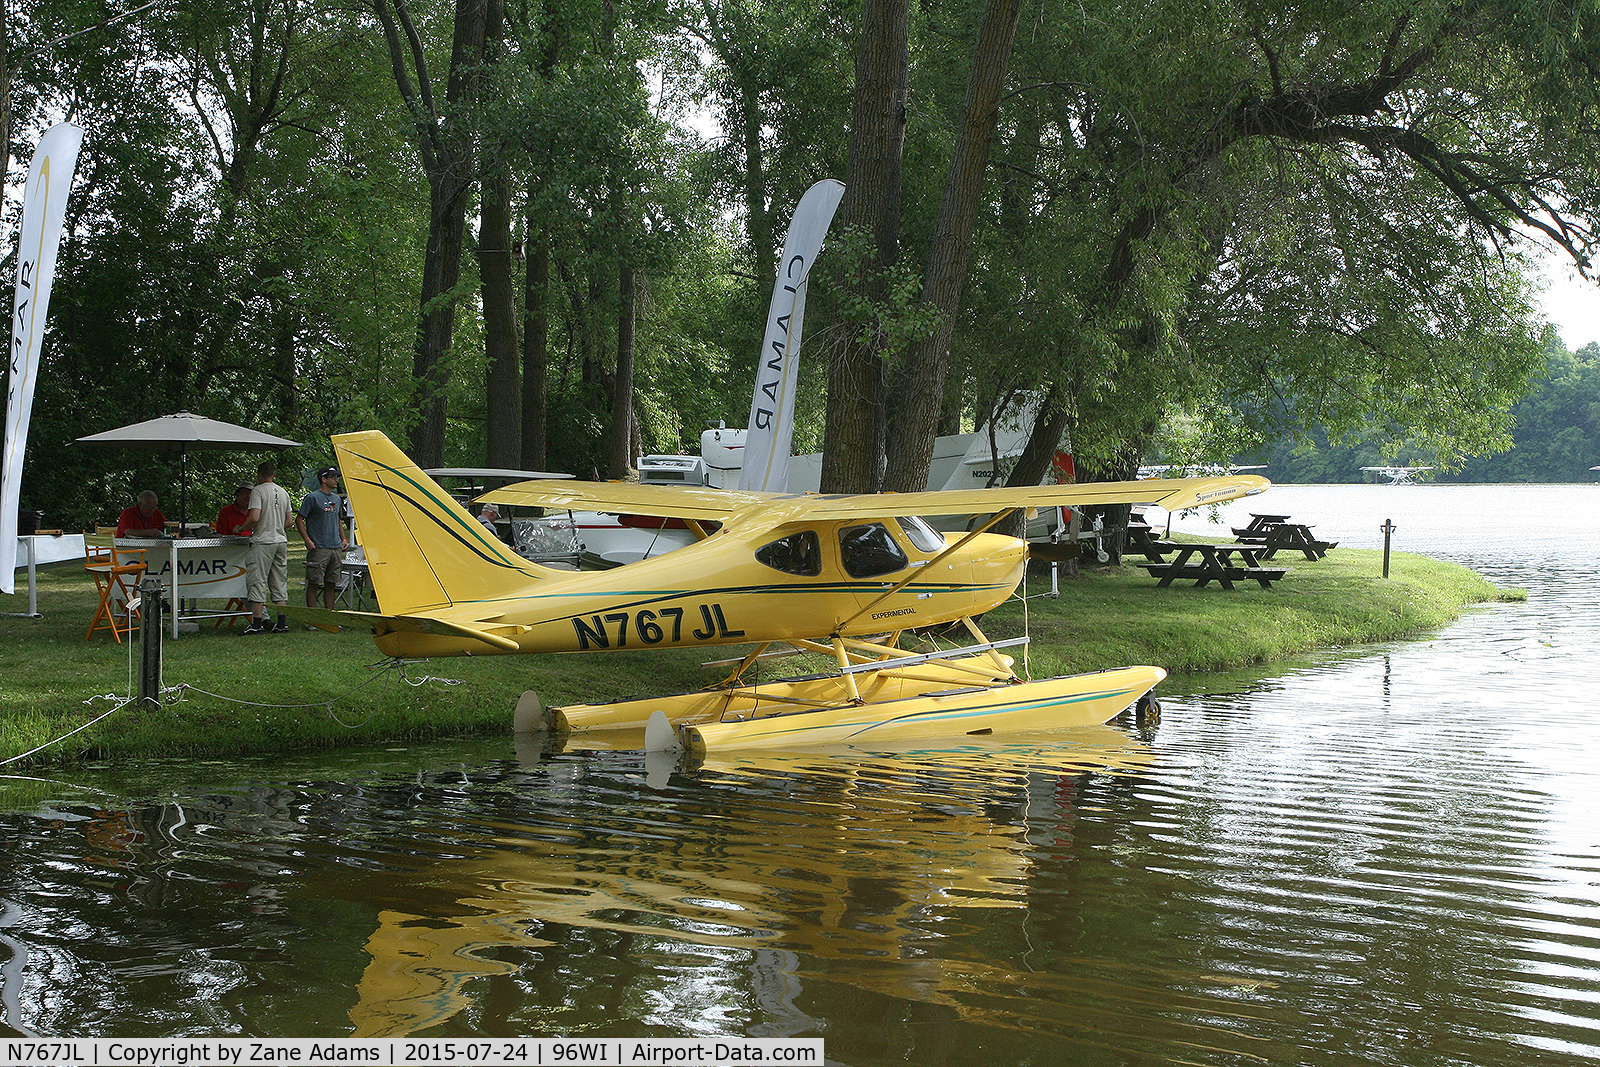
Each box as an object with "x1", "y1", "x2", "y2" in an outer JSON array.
[{"x1": 477, "y1": 475, "x2": 1272, "y2": 522}]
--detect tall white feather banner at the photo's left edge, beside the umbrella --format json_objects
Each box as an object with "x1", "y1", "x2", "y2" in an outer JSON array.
[{"x1": 0, "y1": 122, "x2": 83, "y2": 593}]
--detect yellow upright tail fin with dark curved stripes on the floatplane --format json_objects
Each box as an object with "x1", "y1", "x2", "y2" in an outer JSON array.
[{"x1": 331, "y1": 430, "x2": 555, "y2": 616}]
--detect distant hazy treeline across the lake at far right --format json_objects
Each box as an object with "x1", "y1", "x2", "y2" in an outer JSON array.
[{"x1": 1246, "y1": 341, "x2": 1600, "y2": 482}]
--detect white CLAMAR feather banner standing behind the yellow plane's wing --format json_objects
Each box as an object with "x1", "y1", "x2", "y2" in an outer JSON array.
[{"x1": 739, "y1": 178, "x2": 845, "y2": 493}]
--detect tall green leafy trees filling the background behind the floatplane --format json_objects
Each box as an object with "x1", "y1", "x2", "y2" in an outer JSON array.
[{"x1": 9, "y1": 0, "x2": 1600, "y2": 525}]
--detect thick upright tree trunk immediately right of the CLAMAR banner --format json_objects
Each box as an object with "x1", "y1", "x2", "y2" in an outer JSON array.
[{"x1": 822, "y1": 0, "x2": 909, "y2": 493}]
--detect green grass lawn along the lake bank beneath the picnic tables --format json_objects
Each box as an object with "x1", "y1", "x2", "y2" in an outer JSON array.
[{"x1": 0, "y1": 549, "x2": 1518, "y2": 771}]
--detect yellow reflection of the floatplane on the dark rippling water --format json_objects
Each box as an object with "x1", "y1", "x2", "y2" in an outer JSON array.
[{"x1": 350, "y1": 726, "x2": 1154, "y2": 1037}]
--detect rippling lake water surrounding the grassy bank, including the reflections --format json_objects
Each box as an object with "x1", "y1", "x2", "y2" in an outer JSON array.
[{"x1": 0, "y1": 485, "x2": 1600, "y2": 1067}]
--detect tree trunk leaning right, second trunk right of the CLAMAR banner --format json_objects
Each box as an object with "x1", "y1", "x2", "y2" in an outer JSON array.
[{"x1": 883, "y1": 0, "x2": 1022, "y2": 493}]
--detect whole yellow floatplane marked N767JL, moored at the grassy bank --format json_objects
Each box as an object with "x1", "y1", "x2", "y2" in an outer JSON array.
[{"x1": 318, "y1": 432, "x2": 1267, "y2": 752}]
